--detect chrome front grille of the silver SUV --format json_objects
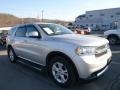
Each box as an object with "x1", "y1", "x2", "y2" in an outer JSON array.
[{"x1": 95, "y1": 44, "x2": 108, "y2": 57}]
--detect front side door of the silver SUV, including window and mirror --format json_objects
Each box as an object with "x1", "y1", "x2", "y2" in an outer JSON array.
[{"x1": 26, "y1": 25, "x2": 42, "y2": 64}]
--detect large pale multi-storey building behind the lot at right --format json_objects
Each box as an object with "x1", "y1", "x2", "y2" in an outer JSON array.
[{"x1": 74, "y1": 8, "x2": 120, "y2": 30}]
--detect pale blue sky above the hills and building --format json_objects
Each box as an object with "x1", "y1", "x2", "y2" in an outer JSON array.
[{"x1": 0, "y1": 0, "x2": 120, "y2": 21}]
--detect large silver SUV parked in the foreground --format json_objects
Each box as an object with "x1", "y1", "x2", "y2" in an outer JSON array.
[{"x1": 7, "y1": 23, "x2": 111, "y2": 87}]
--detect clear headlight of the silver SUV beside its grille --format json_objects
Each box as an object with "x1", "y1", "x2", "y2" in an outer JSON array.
[{"x1": 75, "y1": 46, "x2": 96, "y2": 55}]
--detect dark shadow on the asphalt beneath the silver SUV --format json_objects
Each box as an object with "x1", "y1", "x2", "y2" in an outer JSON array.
[{"x1": 16, "y1": 58, "x2": 109, "y2": 90}]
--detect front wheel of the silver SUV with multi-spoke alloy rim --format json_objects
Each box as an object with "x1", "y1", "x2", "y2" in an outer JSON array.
[{"x1": 49, "y1": 56, "x2": 77, "y2": 87}]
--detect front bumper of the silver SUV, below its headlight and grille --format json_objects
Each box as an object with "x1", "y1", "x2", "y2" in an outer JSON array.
[{"x1": 73, "y1": 49, "x2": 112, "y2": 80}]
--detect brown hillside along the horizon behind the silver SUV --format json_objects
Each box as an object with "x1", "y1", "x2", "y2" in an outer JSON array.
[{"x1": 0, "y1": 13, "x2": 69, "y2": 27}]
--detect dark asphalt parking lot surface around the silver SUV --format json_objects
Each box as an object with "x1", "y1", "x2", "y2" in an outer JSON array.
[{"x1": 0, "y1": 45, "x2": 120, "y2": 90}]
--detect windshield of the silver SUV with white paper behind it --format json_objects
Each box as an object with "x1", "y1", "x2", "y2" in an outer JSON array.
[{"x1": 39, "y1": 24, "x2": 73, "y2": 35}]
